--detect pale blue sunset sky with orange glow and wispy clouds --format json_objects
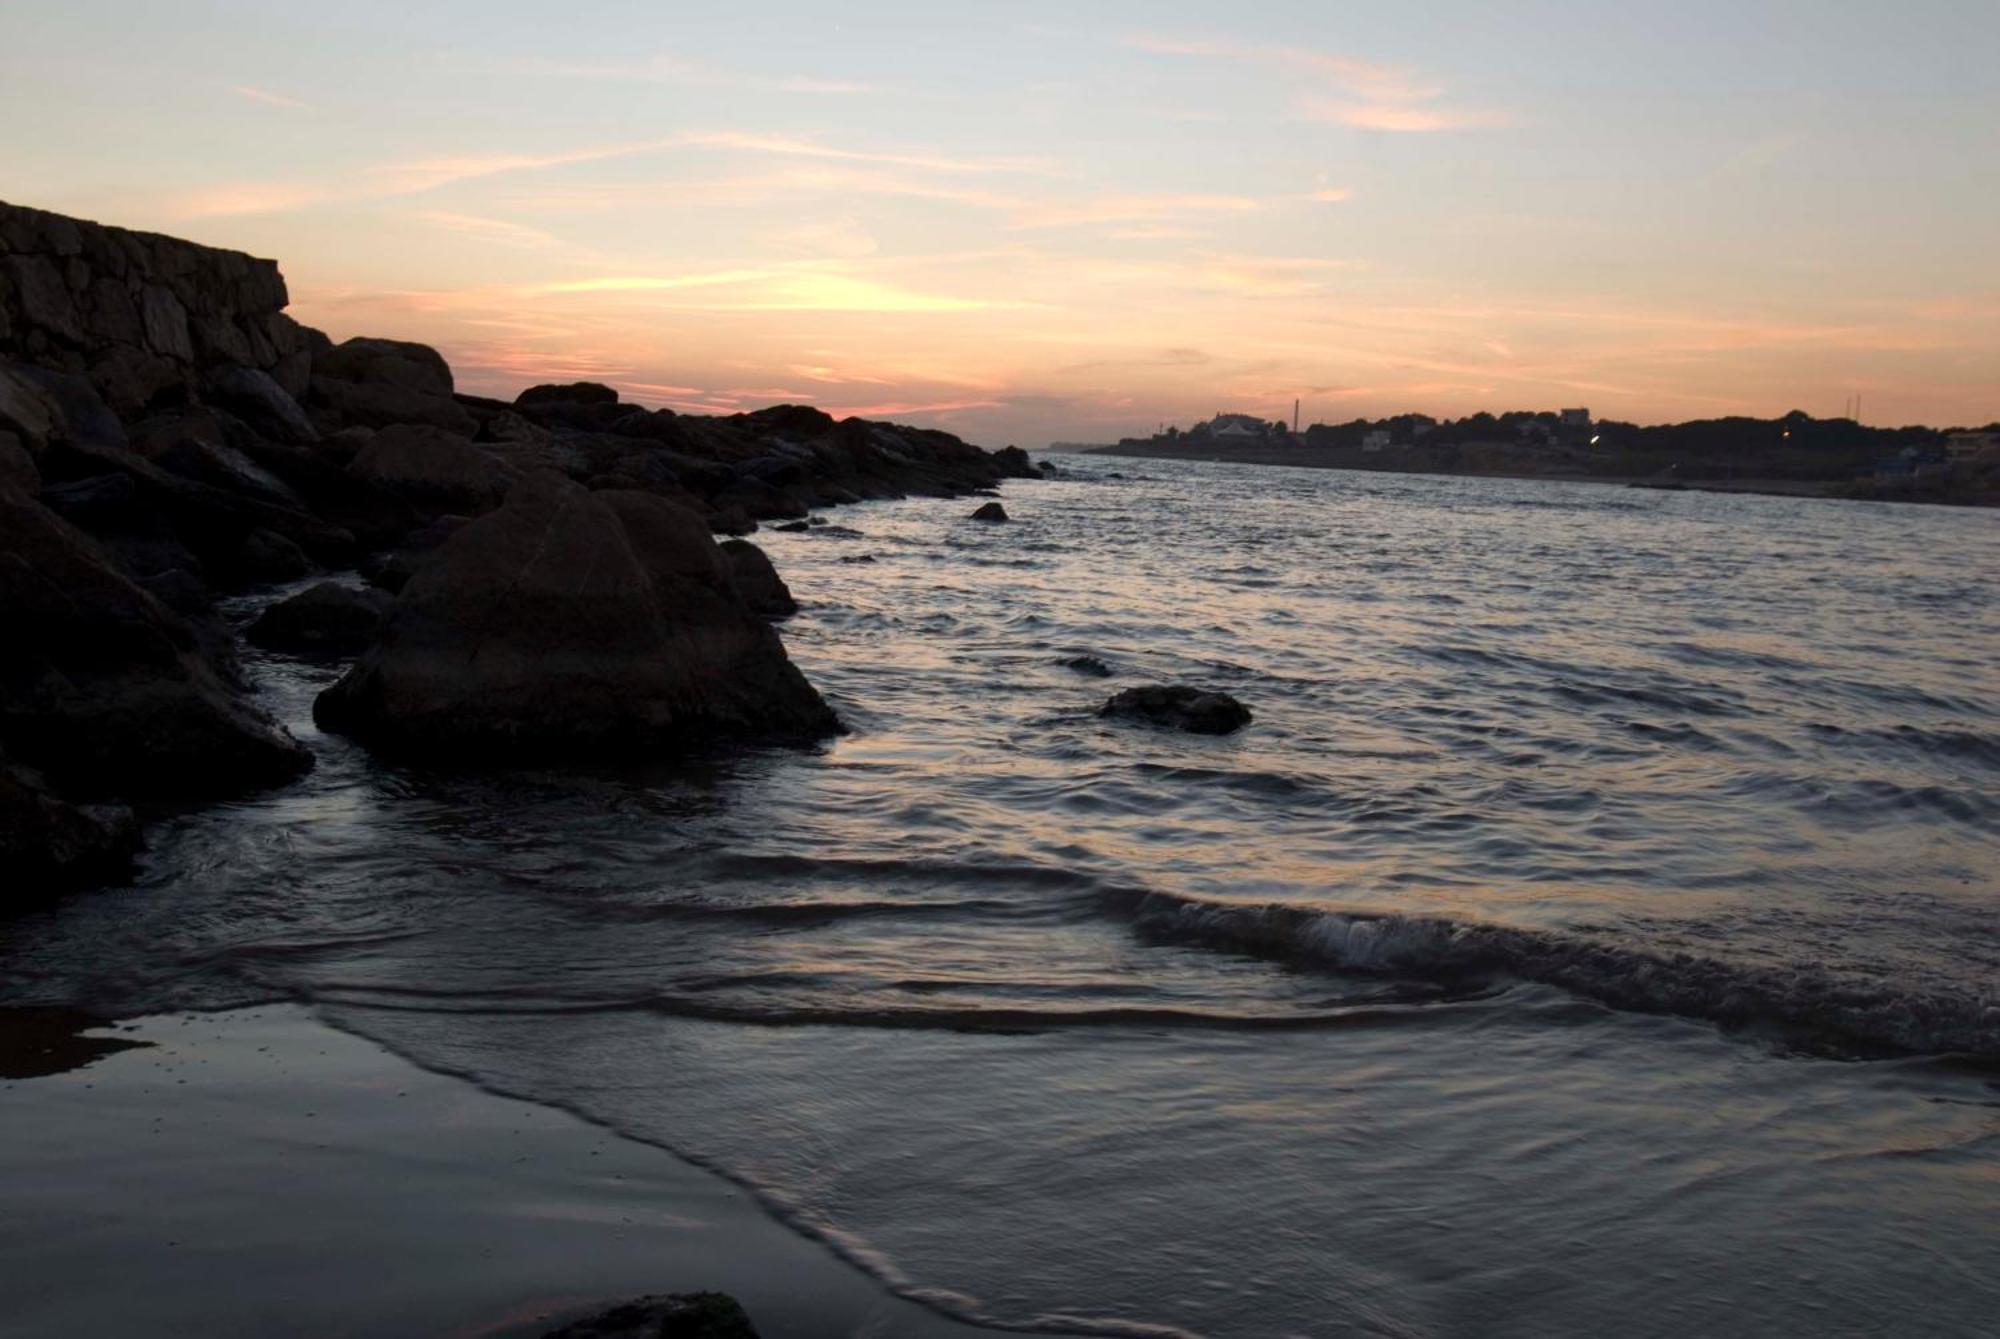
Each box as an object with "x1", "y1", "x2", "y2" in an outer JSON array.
[{"x1": 0, "y1": 0, "x2": 2000, "y2": 446}]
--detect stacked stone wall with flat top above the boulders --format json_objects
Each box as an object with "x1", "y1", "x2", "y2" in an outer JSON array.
[{"x1": 0, "y1": 204, "x2": 310, "y2": 414}]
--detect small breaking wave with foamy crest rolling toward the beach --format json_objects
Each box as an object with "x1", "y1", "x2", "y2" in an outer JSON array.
[{"x1": 1124, "y1": 893, "x2": 2000, "y2": 1061}]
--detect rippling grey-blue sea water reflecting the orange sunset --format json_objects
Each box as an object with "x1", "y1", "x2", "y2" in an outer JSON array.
[{"x1": 0, "y1": 458, "x2": 2000, "y2": 1337}]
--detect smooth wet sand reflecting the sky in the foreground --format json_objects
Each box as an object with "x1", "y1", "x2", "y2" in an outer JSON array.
[{"x1": 0, "y1": 1005, "x2": 1016, "y2": 1339}]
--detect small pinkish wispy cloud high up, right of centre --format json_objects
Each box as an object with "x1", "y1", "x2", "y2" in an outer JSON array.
[{"x1": 1124, "y1": 36, "x2": 1512, "y2": 134}]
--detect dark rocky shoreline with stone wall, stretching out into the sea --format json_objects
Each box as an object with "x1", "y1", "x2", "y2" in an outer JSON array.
[{"x1": 0, "y1": 204, "x2": 1038, "y2": 909}]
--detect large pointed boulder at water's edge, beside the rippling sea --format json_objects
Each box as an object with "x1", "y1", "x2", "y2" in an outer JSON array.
[{"x1": 314, "y1": 472, "x2": 840, "y2": 761}]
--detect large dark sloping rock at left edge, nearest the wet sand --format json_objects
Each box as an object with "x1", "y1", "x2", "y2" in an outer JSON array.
[{"x1": 0, "y1": 492, "x2": 312, "y2": 801}]
